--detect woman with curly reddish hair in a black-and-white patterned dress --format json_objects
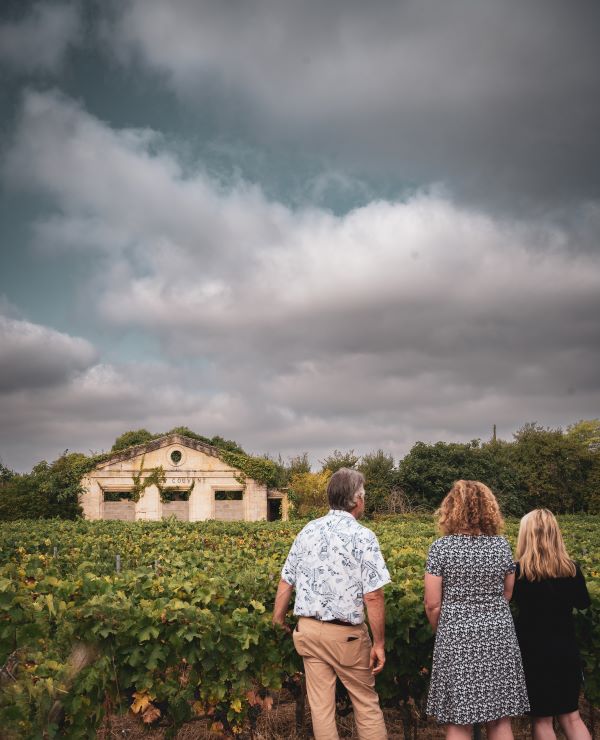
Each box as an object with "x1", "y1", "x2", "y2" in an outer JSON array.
[{"x1": 425, "y1": 480, "x2": 529, "y2": 740}]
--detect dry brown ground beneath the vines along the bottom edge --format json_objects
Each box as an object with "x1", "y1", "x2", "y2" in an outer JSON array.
[{"x1": 97, "y1": 692, "x2": 600, "y2": 740}]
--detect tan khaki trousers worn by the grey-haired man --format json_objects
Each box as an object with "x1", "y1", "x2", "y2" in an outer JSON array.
[{"x1": 293, "y1": 617, "x2": 387, "y2": 740}]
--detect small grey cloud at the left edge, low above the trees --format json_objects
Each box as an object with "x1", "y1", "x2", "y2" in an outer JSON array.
[{"x1": 0, "y1": 316, "x2": 96, "y2": 393}]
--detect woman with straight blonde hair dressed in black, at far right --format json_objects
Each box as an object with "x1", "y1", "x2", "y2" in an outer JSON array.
[{"x1": 513, "y1": 509, "x2": 590, "y2": 740}]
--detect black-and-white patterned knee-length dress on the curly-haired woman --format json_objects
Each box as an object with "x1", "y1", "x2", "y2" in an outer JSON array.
[{"x1": 427, "y1": 534, "x2": 529, "y2": 725}]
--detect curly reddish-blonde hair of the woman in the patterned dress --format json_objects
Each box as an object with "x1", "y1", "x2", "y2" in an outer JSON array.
[{"x1": 436, "y1": 480, "x2": 504, "y2": 535}]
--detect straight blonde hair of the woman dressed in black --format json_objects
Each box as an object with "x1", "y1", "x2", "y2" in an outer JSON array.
[{"x1": 516, "y1": 509, "x2": 576, "y2": 581}]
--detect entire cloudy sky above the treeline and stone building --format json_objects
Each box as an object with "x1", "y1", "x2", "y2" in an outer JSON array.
[{"x1": 0, "y1": 0, "x2": 600, "y2": 470}]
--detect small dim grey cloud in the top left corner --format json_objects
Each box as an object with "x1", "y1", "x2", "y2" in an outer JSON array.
[{"x1": 0, "y1": 2, "x2": 83, "y2": 73}]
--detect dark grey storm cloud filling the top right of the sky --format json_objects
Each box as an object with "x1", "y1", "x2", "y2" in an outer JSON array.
[{"x1": 109, "y1": 0, "x2": 600, "y2": 211}]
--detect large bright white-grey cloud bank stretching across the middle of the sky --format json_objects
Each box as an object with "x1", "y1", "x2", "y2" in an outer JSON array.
[{"x1": 3, "y1": 86, "x2": 600, "y2": 463}]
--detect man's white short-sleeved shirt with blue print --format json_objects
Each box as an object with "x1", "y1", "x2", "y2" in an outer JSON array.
[{"x1": 281, "y1": 509, "x2": 391, "y2": 624}]
